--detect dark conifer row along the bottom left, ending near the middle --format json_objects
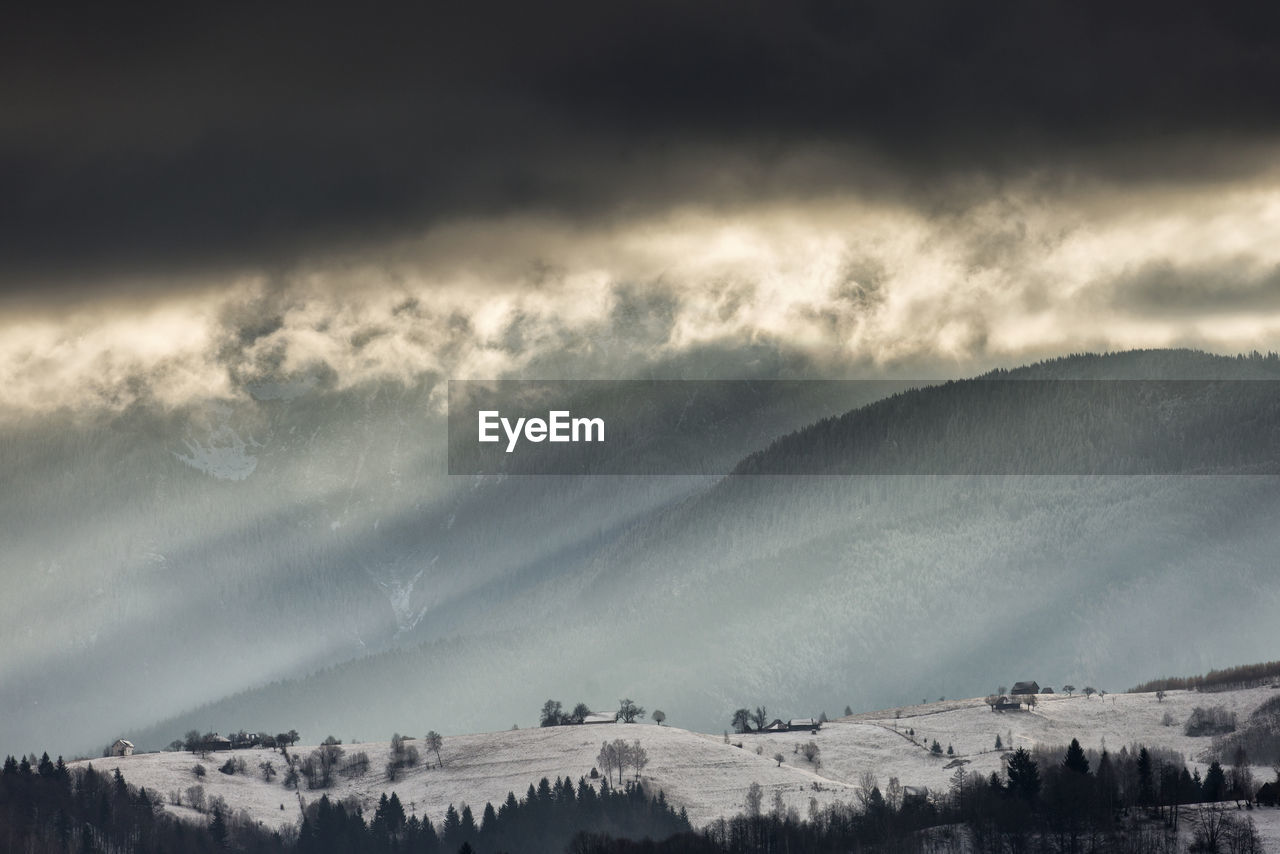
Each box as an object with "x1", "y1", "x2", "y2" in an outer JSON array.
[{"x1": 0, "y1": 754, "x2": 691, "y2": 854}]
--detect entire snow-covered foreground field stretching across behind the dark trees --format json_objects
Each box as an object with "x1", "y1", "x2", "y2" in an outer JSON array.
[{"x1": 77, "y1": 688, "x2": 1280, "y2": 834}]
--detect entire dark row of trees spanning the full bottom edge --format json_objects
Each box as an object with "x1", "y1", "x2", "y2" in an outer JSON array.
[{"x1": 10, "y1": 739, "x2": 1280, "y2": 854}]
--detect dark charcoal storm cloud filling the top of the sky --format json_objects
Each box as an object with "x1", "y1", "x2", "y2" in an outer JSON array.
[{"x1": 0, "y1": 0, "x2": 1280, "y2": 288}]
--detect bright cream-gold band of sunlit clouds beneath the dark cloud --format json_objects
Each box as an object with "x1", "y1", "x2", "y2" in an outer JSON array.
[{"x1": 0, "y1": 175, "x2": 1280, "y2": 411}]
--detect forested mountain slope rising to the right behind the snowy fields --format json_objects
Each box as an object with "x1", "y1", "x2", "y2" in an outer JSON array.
[{"x1": 122, "y1": 352, "x2": 1280, "y2": 743}]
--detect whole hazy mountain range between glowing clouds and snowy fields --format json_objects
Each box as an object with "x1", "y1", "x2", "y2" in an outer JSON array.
[{"x1": 0, "y1": 351, "x2": 1280, "y2": 753}]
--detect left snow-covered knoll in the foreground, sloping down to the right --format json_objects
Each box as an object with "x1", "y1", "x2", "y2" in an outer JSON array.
[{"x1": 77, "y1": 723, "x2": 852, "y2": 825}]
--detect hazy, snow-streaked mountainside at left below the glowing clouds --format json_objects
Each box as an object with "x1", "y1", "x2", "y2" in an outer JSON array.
[{"x1": 0, "y1": 383, "x2": 860, "y2": 753}]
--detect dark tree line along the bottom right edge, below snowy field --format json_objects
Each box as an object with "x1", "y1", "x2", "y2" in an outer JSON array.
[{"x1": 571, "y1": 740, "x2": 1280, "y2": 854}]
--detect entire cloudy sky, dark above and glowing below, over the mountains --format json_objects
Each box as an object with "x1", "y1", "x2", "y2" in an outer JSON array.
[{"x1": 0, "y1": 0, "x2": 1280, "y2": 414}]
